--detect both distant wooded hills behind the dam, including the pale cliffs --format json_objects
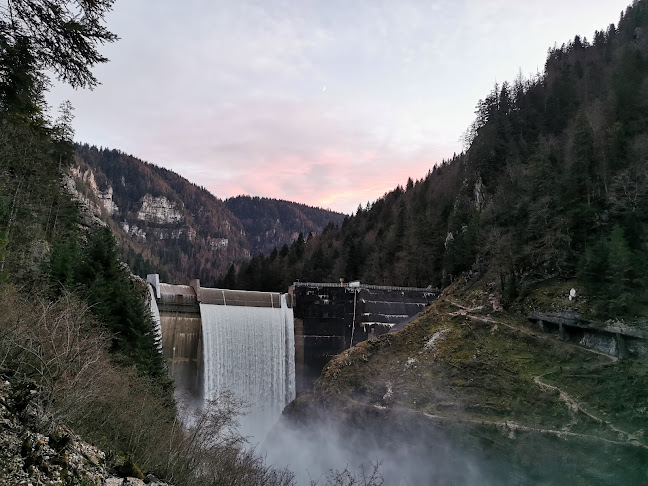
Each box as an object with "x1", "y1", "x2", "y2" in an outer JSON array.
[{"x1": 71, "y1": 144, "x2": 343, "y2": 286}]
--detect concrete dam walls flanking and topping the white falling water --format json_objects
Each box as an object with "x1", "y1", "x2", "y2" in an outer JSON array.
[{"x1": 147, "y1": 275, "x2": 439, "y2": 403}]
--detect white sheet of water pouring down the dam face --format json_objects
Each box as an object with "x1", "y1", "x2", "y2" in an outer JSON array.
[{"x1": 200, "y1": 294, "x2": 295, "y2": 439}]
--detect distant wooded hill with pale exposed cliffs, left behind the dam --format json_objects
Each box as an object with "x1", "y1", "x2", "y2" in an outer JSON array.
[{"x1": 73, "y1": 145, "x2": 250, "y2": 284}]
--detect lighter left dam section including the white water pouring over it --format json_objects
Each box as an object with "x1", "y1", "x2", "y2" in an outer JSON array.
[{"x1": 147, "y1": 275, "x2": 295, "y2": 438}]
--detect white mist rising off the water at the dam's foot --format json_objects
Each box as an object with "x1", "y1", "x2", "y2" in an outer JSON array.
[{"x1": 258, "y1": 410, "x2": 486, "y2": 486}]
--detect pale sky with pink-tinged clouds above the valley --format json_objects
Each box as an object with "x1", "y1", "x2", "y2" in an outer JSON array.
[{"x1": 48, "y1": 0, "x2": 630, "y2": 213}]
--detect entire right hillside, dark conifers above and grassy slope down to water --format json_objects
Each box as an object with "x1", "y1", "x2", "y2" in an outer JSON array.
[{"x1": 280, "y1": 5, "x2": 648, "y2": 486}]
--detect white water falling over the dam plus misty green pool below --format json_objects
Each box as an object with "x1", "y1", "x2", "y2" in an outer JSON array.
[{"x1": 187, "y1": 297, "x2": 636, "y2": 486}]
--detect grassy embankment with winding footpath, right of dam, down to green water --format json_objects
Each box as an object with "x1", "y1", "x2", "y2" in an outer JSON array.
[{"x1": 285, "y1": 285, "x2": 648, "y2": 485}]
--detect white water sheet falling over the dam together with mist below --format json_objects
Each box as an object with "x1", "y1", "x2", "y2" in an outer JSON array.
[{"x1": 200, "y1": 296, "x2": 489, "y2": 486}]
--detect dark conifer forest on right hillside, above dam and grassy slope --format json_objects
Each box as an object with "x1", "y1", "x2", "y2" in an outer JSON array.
[{"x1": 234, "y1": 1, "x2": 648, "y2": 315}]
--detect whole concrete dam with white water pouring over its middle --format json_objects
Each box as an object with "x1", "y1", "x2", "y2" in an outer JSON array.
[{"x1": 147, "y1": 274, "x2": 439, "y2": 437}]
